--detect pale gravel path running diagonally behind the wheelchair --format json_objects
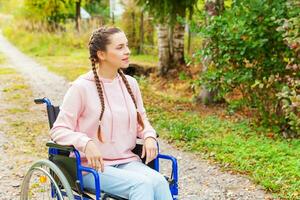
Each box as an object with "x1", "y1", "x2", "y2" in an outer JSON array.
[{"x1": 0, "y1": 34, "x2": 271, "y2": 200}]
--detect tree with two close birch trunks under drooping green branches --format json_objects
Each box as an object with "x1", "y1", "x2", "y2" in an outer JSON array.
[{"x1": 136, "y1": 0, "x2": 197, "y2": 76}]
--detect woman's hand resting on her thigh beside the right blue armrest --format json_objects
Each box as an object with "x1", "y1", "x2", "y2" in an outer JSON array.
[{"x1": 142, "y1": 137, "x2": 158, "y2": 165}]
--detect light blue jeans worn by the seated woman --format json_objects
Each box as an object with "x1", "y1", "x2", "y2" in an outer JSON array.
[{"x1": 83, "y1": 161, "x2": 173, "y2": 200}]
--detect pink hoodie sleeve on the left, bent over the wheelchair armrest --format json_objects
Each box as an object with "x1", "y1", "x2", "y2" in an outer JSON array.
[{"x1": 50, "y1": 84, "x2": 91, "y2": 152}]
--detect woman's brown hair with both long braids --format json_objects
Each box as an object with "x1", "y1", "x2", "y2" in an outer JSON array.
[{"x1": 89, "y1": 27, "x2": 145, "y2": 142}]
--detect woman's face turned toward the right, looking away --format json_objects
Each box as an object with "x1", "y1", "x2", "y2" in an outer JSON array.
[{"x1": 98, "y1": 32, "x2": 130, "y2": 69}]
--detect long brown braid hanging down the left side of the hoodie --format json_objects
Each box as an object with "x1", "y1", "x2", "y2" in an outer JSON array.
[{"x1": 91, "y1": 58, "x2": 105, "y2": 142}]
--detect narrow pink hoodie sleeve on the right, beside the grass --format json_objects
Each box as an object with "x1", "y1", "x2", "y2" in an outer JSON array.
[{"x1": 133, "y1": 79, "x2": 156, "y2": 139}]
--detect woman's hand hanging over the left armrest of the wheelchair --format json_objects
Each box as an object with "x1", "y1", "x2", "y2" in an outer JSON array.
[{"x1": 84, "y1": 140, "x2": 104, "y2": 172}]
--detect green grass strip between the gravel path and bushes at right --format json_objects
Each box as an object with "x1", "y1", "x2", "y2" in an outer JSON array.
[{"x1": 139, "y1": 79, "x2": 300, "y2": 199}]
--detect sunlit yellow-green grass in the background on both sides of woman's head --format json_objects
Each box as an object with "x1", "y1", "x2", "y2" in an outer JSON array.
[{"x1": 3, "y1": 25, "x2": 158, "y2": 80}]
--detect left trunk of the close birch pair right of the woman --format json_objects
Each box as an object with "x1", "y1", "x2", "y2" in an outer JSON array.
[{"x1": 157, "y1": 24, "x2": 170, "y2": 76}]
